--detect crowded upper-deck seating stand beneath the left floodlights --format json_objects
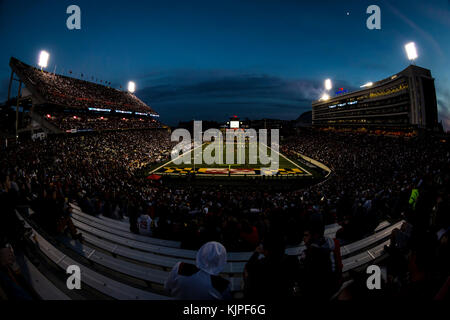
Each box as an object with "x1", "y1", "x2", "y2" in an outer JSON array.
[{"x1": 9, "y1": 57, "x2": 157, "y2": 114}]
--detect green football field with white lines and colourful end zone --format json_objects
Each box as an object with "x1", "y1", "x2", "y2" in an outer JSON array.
[{"x1": 150, "y1": 142, "x2": 311, "y2": 176}]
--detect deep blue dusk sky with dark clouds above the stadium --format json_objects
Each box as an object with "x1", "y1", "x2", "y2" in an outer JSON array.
[{"x1": 0, "y1": 0, "x2": 450, "y2": 129}]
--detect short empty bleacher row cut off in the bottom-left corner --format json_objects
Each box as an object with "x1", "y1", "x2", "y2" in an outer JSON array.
[{"x1": 21, "y1": 256, "x2": 70, "y2": 300}]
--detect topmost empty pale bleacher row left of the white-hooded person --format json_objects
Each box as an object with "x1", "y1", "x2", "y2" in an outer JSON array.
[{"x1": 72, "y1": 210, "x2": 181, "y2": 248}]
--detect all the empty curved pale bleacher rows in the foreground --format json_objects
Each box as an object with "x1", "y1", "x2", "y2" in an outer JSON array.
[{"x1": 14, "y1": 205, "x2": 402, "y2": 299}]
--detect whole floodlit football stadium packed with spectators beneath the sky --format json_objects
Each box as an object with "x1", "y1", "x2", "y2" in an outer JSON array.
[{"x1": 0, "y1": 1, "x2": 450, "y2": 310}]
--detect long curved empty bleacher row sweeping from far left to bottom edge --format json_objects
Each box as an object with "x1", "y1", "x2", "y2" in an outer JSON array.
[{"x1": 16, "y1": 212, "x2": 169, "y2": 300}]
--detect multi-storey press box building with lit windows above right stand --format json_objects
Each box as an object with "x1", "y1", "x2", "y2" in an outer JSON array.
[{"x1": 312, "y1": 65, "x2": 438, "y2": 130}]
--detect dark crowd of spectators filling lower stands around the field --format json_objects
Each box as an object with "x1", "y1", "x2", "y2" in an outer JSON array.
[{"x1": 1, "y1": 130, "x2": 450, "y2": 298}]
